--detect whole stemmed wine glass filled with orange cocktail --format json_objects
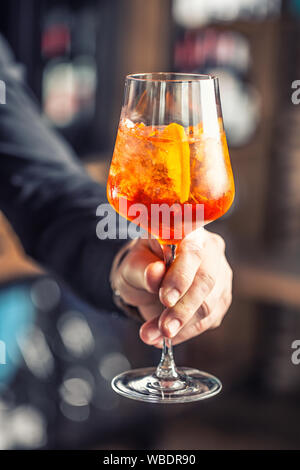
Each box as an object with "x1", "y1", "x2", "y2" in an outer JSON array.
[{"x1": 107, "y1": 73, "x2": 234, "y2": 403}]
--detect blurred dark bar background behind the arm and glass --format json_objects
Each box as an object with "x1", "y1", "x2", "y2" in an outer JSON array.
[{"x1": 0, "y1": 0, "x2": 300, "y2": 449}]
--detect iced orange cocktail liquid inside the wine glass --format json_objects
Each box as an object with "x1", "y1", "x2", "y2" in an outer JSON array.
[{"x1": 107, "y1": 119, "x2": 234, "y2": 244}]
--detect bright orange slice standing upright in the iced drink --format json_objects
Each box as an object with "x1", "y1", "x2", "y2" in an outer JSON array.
[{"x1": 159, "y1": 122, "x2": 191, "y2": 203}]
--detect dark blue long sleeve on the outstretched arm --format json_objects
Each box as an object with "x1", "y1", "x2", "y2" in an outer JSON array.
[{"x1": 0, "y1": 38, "x2": 124, "y2": 310}]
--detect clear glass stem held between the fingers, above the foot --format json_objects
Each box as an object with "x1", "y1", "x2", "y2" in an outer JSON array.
[{"x1": 155, "y1": 245, "x2": 179, "y2": 380}]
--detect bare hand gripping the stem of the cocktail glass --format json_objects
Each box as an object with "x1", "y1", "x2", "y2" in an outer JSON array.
[{"x1": 111, "y1": 229, "x2": 232, "y2": 347}]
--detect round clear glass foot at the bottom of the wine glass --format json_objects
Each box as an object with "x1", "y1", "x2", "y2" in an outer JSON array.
[{"x1": 111, "y1": 367, "x2": 222, "y2": 403}]
